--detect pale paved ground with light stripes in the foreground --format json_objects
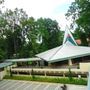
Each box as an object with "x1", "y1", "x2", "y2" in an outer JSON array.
[{"x1": 0, "y1": 80, "x2": 87, "y2": 90}]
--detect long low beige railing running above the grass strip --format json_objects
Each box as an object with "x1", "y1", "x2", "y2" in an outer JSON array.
[{"x1": 11, "y1": 68, "x2": 88, "y2": 77}]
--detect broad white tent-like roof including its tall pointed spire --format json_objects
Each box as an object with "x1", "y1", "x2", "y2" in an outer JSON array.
[{"x1": 36, "y1": 30, "x2": 90, "y2": 63}]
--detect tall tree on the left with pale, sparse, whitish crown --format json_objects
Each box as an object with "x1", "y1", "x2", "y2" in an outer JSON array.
[{"x1": 0, "y1": 8, "x2": 28, "y2": 58}]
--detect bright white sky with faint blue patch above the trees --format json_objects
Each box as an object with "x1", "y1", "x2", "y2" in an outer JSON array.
[{"x1": 4, "y1": 0, "x2": 74, "y2": 30}]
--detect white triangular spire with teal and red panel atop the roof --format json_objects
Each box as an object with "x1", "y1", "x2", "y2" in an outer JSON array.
[{"x1": 63, "y1": 29, "x2": 77, "y2": 46}]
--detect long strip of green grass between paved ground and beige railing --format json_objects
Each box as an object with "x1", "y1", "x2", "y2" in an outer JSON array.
[{"x1": 4, "y1": 76, "x2": 87, "y2": 85}]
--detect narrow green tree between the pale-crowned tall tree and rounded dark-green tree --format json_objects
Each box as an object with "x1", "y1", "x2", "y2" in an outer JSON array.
[{"x1": 21, "y1": 17, "x2": 38, "y2": 57}]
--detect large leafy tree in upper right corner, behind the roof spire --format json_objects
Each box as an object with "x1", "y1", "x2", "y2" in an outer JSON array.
[{"x1": 66, "y1": 0, "x2": 90, "y2": 45}]
